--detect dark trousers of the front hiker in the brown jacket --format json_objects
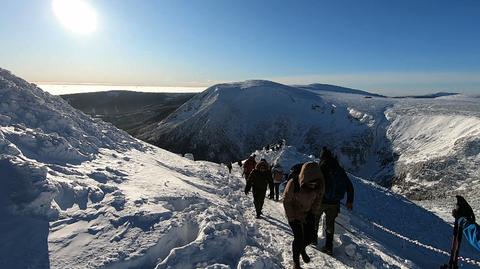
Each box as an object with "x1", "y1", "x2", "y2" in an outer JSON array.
[{"x1": 288, "y1": 215, "x2": 315, "y2": 265}]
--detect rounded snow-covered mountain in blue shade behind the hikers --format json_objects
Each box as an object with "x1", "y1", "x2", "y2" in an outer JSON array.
[{"x1": 140, "y1": 80, "x2": 386, "y2": 180}]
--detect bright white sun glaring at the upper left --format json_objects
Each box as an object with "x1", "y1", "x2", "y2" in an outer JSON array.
[{"x1": 52, "y1": 0, "x2": 97, "y2": 34}]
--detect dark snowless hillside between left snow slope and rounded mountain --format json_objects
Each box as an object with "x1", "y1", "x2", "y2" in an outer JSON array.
[{"x1": 61, "y1": 91, "x2": 195, "y2": 136}]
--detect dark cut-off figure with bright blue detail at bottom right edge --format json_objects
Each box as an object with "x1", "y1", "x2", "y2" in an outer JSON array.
[{"x1": 440, "y1": 195, "x2": 480, "y2": 269}]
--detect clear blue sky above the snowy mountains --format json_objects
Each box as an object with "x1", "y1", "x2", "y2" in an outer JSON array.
[{"x1": 0, "y1": 0, "x2": 480, "y2": 95}]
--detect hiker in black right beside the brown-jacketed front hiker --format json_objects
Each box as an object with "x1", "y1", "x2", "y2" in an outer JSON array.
[{"x1": 313, "y1": 147, "x2": 354, "y2": 255}]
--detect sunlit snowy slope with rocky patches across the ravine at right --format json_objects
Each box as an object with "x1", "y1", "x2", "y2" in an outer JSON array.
[{"x1": 386, "y1": 97, "x2": 480, "y2": 210}]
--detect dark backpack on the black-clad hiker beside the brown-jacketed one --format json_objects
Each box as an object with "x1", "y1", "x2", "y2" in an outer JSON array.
[{"x1": 322, "y1": 161, "x2": 349, "y2": 203}]
